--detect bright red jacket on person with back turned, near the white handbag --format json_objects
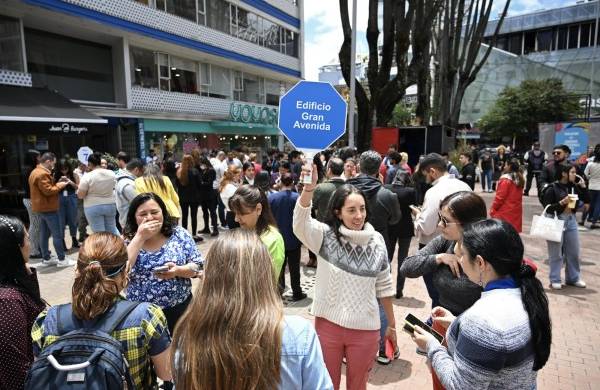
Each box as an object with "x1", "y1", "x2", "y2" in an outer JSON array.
[{"x1": 490, "y1": 175, "x2": 523, "y2": 233}]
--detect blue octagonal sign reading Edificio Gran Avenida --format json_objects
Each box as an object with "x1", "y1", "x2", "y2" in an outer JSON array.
[{"x1": 279, "y1": 80, "x2": 347, "y2": 152}]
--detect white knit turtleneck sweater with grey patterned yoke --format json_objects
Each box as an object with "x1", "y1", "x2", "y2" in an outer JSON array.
[{"x1": 294, "y1": 202, "x2": 395, "y2": 330}]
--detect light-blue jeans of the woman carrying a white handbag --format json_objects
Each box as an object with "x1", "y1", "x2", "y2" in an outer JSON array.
[{"x1": 546, "y1": 214, "x2": 580, "y2": 283}]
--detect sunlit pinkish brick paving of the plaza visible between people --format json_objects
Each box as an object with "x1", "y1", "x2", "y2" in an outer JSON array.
[{"x1": 32, "y1": 184, "x2": 600, "y2": 390}]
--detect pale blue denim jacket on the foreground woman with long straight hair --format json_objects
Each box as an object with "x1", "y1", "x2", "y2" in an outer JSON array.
[{"x1": 279, "y1": 316, "x2": 333, "y2": 390}]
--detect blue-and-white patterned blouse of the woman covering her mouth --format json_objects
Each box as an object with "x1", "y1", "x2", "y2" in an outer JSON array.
[{"x1": 126, "y1": 226, "x2": 204, "y2": 308}]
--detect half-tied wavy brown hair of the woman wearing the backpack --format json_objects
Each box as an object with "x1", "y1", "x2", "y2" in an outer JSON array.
[{"x1": 71, "y1": 232, "x2": 128, "y2": 320}]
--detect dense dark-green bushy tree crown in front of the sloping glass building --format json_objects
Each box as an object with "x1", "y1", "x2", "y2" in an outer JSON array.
[{"x1": 479, "y1": 78, "x2": 581, "y2": 137}]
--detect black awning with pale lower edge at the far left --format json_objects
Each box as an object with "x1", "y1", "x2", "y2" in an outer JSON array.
[{"x1": 0, "y1": 85, "x2": 108, "y2": 123}]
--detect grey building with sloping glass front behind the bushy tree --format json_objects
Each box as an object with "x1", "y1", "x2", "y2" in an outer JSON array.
[{"x1": 460, "y1": 0, "x2": 600, "y2": 123}]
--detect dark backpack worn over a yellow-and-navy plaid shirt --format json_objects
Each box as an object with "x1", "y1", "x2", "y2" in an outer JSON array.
[{"x1": 25, "y1": 300, "x2": 138, "y2": 390}]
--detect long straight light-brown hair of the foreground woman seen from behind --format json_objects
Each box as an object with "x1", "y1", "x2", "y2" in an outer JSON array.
[{"x1": 172, "y1": 229, "x2": 283, "y2": 390}]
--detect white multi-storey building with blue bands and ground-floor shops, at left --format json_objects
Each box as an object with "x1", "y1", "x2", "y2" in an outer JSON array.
[{"x1": 0, "y1": 0, "x2": 304, "y2": 193}]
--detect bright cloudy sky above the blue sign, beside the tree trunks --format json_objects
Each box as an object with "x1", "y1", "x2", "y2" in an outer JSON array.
[{"x1": 304, "y1": 0, "x2": 369, "y2": 80}]
